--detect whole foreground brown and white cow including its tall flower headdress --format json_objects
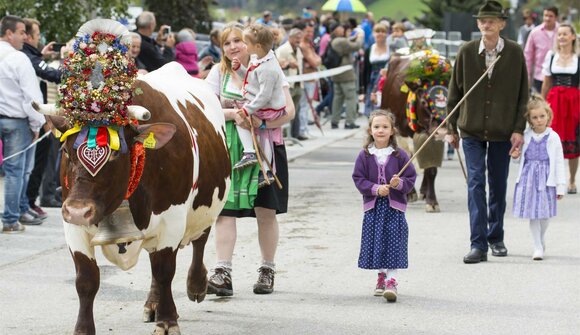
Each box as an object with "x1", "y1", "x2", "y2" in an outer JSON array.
[{"x1": 36, "y1": 19, "x2": 231, "y2": 335}]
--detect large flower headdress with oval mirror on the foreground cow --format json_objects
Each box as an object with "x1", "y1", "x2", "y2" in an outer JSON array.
[{"x1": 59, "y1": 31, "x2": 137, "y2": 127}]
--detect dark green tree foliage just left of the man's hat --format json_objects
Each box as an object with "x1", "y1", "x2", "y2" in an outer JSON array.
[{"x1": 417, "y1": 0, "x2": 482, "y2": 30}]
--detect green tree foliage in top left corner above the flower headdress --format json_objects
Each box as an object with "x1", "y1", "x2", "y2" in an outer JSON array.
[{"x1": 0, "y1": 0, "x2": 131, "y2": 42}]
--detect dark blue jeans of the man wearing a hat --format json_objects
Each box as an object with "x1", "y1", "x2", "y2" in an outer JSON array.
[{"x1": 462, "y1": 138, "x2": 511, "y2": 251}]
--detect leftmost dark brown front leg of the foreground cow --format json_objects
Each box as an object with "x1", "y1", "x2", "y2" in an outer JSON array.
[{"x1": 71, "y1": 251, "x2": 100, "y2": 335}]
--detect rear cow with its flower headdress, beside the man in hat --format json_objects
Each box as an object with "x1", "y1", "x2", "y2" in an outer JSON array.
[{"x1": 381, "y1": 29, "x2": 451, "y2": 212}]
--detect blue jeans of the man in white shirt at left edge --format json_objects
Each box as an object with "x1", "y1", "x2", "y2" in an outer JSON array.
[{"x1": 0, "y1": 118, "x2": 34, "y2": 224}]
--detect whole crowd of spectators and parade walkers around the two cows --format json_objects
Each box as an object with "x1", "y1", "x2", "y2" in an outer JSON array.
[{"x1": 0, "y1": 1, "x2": 580, "y2": 301}]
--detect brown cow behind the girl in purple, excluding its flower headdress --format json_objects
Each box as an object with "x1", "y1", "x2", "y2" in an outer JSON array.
[{"x1": 381, "y1": 54, "x2": 444, "y2": 212}]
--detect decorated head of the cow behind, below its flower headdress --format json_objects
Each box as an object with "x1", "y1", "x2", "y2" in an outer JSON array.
[{"x1": 405, "y1": 81, "x2": 448, "y2": 137}]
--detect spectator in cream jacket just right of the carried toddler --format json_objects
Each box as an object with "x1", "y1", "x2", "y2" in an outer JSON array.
[{"x1": 276, "y1": 28, "x2": 304, "y2": 138}]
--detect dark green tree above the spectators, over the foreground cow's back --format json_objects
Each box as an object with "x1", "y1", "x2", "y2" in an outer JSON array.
[{"x1": 145, "y1": 0, "x2": 212, "y2": 33}]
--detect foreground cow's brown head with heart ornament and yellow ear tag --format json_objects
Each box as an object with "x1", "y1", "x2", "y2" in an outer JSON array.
[{"x1": 48, "y1": 106, "x2": 176, "y2": 226}]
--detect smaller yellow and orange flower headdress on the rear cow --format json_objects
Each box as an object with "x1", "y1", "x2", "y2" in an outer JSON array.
[{"x1": 405, "y1": 50, "x2": 451, "y2": 85}]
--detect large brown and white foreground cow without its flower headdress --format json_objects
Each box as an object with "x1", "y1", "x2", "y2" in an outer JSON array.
[{"x1": 39, "y1": 63, "x2": 231, "y2": 335}]
